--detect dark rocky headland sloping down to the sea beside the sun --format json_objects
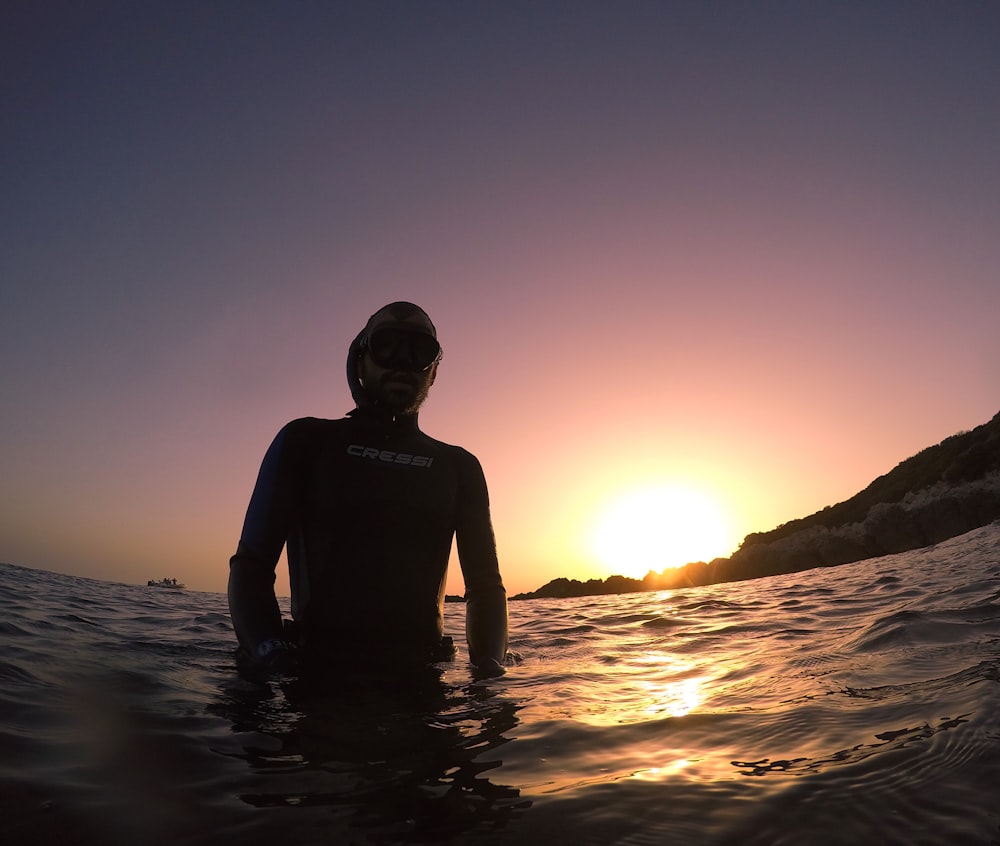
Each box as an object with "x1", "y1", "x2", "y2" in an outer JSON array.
[{"x1": 512, "y1": 414, "x2": 1000, "y2": 599}]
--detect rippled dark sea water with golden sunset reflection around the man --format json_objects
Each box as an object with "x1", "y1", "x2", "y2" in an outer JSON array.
[{"x1": 0, "y1": 524, "x2": 1000, "y2": 846}]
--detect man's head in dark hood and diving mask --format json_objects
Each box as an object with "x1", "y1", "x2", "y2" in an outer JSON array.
[{"x1": 347, "y1": 302, "x2": 441, "y2": 414}]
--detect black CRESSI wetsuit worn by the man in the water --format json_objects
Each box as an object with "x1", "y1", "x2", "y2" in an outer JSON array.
[{"x1": 229, "y1": 409, "x2": 506, "y2": 657}]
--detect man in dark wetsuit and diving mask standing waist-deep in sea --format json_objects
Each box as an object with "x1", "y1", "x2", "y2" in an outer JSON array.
[{"x1": 229, "y1": 302, "x2": 507, "y2": 676}]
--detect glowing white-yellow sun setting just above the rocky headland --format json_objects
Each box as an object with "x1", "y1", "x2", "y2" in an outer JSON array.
[{"x1": 590, "y1": 484, "x2": 735, "y2": 578}]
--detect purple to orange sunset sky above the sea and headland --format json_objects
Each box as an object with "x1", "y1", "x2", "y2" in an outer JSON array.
[{"x1": 0, "y1": 0, "x2": 1000, "y2": 594}]
